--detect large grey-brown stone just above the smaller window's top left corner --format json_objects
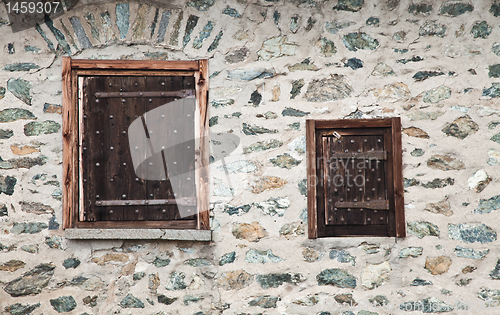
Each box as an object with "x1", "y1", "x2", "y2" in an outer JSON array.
[{"x1": 305, "y1": 74, "x2": 353, "y2": 102}]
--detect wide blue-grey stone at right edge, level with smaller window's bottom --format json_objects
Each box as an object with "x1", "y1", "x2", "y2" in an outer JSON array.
[{"x1": 448, "y1": 223, "x2": 497, "y2": 244}]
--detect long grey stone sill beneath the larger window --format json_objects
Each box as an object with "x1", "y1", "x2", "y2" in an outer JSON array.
[{"x1": 65, "y1": 229, "x2": 212, "y2": 242}]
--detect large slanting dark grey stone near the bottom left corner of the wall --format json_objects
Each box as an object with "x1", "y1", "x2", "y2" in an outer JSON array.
[{"x1": 4, "y1": 263, "x2": 56, "y2": 297}]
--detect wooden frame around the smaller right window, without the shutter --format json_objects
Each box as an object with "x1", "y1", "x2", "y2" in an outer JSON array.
[{"x1": 306, "y1": 117, "x2": 406, "y2": 239}]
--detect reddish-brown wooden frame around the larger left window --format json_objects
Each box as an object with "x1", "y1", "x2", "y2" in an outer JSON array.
[{"x1": 62, "y1": 57, "x2": 210, "y2": 230}]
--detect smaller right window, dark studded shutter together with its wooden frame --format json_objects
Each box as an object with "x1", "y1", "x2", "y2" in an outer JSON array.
[{"x1": 307, "y1": 118, "x2": 404, "y2": 238}]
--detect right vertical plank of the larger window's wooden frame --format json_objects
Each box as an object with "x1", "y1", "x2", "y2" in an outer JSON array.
[{"x1": 195, "y1": 59, "x2": 210, "y2": 230}]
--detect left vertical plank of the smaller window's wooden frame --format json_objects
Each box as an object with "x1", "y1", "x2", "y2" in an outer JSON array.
[{"x1": 306, "y1": 119, "x2": 318, "y2": 238}]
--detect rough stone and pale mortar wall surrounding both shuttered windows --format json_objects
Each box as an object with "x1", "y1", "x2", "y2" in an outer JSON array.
[{"x1": 0, "y1": 0, "x2": 500, "y2": 315}]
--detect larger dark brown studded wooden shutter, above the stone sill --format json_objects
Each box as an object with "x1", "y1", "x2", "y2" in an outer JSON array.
[{"x1": 80, "y1": 76, "x2": 197, "y2": 228}]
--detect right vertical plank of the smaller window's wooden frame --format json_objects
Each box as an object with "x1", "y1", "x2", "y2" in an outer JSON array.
[{"x1": 391, "y1": 117, "x2": 406, "y2": 237}]
